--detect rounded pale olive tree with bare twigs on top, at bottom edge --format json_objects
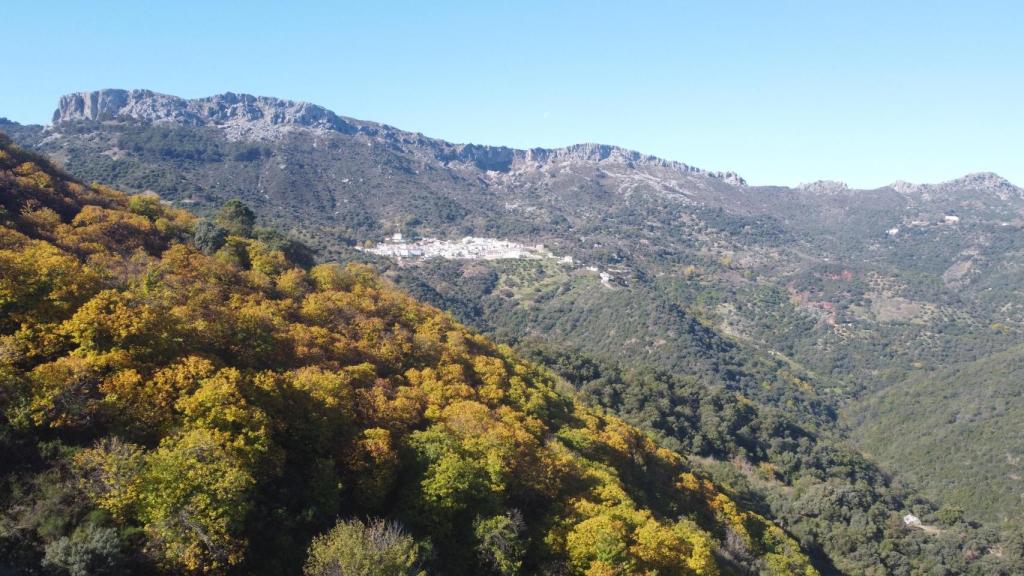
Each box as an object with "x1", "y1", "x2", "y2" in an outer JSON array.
[{"x1": 303, "y1": 520, "x2": 426, "y2": 576}]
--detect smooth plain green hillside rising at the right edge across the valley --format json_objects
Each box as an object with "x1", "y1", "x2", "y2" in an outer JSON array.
[{"x1": 851, "y1": 345, "x2": 1024, "y2": 525}]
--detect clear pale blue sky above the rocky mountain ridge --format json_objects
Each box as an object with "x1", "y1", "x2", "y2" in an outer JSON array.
[{"x1": 0, "y1": 0, "x2": 1024, "y2": 187}]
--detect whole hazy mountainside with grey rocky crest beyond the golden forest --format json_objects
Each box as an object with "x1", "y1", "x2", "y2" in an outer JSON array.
[{"x1": 0, "y1": 90, "x2": 1024, "y2": 574}]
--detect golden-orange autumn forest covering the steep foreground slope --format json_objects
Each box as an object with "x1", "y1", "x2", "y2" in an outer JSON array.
[{"x1": 0, "y1": 135, "x2": 831, "y2": 576}]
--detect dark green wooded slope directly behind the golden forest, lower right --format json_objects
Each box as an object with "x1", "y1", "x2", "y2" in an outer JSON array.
[{"x1": 520, "y1": 340, "x2": 1024, "y2": 575}]
